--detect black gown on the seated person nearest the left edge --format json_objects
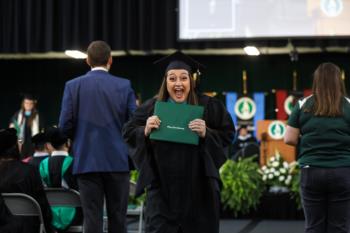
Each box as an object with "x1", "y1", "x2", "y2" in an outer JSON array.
[{"x1": 0, "y1": 160, "x2": 52, "y2": 233}]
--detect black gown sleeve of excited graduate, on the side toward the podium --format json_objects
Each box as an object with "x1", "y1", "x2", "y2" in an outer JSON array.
[{"x1": 200, "y1": 94, "x2": 235, "y2": 180}]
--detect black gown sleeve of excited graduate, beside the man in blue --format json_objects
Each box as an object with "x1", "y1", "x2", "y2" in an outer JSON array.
[{"x1": 123, "y1": 99, "x2": 155, "y2": 196}]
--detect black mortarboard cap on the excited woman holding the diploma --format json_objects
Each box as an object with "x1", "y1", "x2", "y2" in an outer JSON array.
[{"x1": 153, "y1": 51, "x2": 204, "y2": 74}]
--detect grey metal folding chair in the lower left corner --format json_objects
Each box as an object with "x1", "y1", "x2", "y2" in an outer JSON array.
[{"x1": 1, "y1": 193, "x2": 46, "y2": 233}]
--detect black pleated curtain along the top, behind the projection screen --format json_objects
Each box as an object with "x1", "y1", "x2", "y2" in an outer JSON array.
[{"x1": 0, "y1": 0, "x2": 350, "y2": 53}]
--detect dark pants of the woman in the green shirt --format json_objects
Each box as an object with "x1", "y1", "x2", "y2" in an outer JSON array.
[{"x1": 300, "y1": 167, "x2": 350, "y2": 233}]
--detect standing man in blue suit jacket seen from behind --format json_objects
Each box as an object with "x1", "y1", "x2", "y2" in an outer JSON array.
[{"x1": 59, "y1": 41, "x2": 136, "y2": 233}]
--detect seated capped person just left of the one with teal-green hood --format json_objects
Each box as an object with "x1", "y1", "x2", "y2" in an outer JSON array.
[{"x1": 23, "y1": 133, "x2": 50, "y2": 167}]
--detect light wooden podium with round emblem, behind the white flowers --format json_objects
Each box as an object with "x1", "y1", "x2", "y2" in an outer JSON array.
[{"x1": 256, "y1": 120, "x2": 296, "y2": 165}]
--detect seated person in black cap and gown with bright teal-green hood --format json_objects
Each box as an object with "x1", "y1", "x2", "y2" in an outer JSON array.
[{"x1": 40, "y1": 128, "x2": 82, "y2": 232}]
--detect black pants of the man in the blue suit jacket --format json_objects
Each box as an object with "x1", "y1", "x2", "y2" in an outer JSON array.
[{"x1": 78, "y1": 172, "x2": 129, "y2": 233}]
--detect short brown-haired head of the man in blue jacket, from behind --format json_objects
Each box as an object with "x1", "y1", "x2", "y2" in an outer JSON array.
[{"x1": 87, "y1": 40, "x2": 111, "y2": 67}]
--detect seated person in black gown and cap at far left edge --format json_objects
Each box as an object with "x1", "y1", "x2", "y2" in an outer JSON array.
[{"x1": 0, "y1": 128, "x2": 52, "y2": 233}]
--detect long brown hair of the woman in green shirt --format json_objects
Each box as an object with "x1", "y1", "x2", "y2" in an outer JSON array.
[{"x1": 312, "y1": 62, "x2": 346, "y2": 117}]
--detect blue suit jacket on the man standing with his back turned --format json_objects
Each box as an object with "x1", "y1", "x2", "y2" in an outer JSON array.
[{"x1": 59, "y1": 70, "x2": 136, "y2": 174}]
